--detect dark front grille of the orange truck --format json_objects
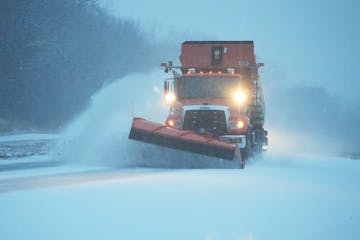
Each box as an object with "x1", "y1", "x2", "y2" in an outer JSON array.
[{"x1": 183, "y1": 110, "x2": 227, "y2": 137}]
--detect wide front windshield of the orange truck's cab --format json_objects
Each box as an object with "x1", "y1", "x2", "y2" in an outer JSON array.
[{"x1": 176, "y1": 76, "x2": 240, "y2": 99}]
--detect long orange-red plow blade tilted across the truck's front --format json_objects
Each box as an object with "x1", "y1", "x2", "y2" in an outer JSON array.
[{"x1": 129, "y1": 118, "x2": 241, "y2": 161}]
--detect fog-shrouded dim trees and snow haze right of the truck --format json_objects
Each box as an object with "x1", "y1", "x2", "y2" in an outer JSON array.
[{"x1": 262, "y1": 65, "x2": 360, "y2": 153}]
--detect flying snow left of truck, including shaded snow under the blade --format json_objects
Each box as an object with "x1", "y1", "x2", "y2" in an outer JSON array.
[{"x1": 53, "y1": 69, "x2": 242, "y2": 168}]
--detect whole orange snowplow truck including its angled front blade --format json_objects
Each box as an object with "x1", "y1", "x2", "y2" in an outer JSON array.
[{"x1": 129, "y1": 41, "x2": 268, "y2": 168}]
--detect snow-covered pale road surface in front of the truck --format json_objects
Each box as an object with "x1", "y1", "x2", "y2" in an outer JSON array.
[{"x1": 0, "y1": 133, "x2": 360, "y2": 240}]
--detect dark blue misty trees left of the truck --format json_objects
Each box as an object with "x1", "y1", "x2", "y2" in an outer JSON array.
[{"x1": 0, "y1": 0, "x2": 167, "y2": 131}]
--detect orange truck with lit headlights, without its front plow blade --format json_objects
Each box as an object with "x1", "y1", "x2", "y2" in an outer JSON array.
[{"x1": 162, "y1": 41, "x2": 267, "y2": 158}]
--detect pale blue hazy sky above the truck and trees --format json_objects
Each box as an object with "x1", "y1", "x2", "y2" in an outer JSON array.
[{"x1": 100, "y1": 0, "x2": 360, "y2": 102}]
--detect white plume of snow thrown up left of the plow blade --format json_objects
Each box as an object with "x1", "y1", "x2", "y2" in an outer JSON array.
[{"x1": 53, "y1": 69, "x2": 168, "y2": 166}]
